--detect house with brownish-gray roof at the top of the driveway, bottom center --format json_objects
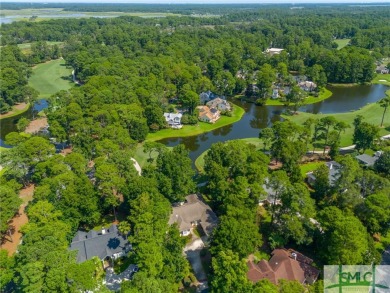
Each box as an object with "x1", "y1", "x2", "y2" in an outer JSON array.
[{"x1": 168, "y1": 194, "x2": 218, "y2": 236}]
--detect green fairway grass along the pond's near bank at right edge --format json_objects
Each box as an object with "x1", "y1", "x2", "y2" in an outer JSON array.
[{"x1": 282, "y1": 103, "x2": 390, "y2": 147}]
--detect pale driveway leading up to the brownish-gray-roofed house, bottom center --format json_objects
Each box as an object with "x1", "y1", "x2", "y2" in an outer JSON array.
[{"x1": 184, "y1": 233, "x2": 208, "y2": 292}]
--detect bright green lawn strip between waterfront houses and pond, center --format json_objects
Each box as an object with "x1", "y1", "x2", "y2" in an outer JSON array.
[{"x1": 146, "y1": 105, "x2": 245, "y2": 141}]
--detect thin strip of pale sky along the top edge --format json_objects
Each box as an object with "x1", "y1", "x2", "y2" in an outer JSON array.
[{"x1": 3, "y1": 0, "x2": 390, "y2": 4}]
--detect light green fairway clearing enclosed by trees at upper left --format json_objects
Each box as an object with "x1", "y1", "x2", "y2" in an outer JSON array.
[{"x1": 29, "y1": 59, "x2": 74, "y2": 99}]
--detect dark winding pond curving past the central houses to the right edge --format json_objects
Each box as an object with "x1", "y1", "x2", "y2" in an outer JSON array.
[{"x1": 159, "y1": 84, "x2": 388, "y2": 161}]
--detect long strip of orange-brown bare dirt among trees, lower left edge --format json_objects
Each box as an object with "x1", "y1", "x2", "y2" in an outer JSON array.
[{"x1": 0, "y1": 184, "x2": 34, "y2": 255}]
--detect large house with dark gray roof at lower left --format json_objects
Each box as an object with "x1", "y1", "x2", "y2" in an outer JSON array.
[{"x1": 69, "y1": 224, "x2": 131, "y2": 263}]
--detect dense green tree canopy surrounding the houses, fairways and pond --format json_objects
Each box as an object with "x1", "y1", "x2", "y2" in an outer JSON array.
[{"x1": 0, "y1": 4, "x2": 390, "y2": 293}]
